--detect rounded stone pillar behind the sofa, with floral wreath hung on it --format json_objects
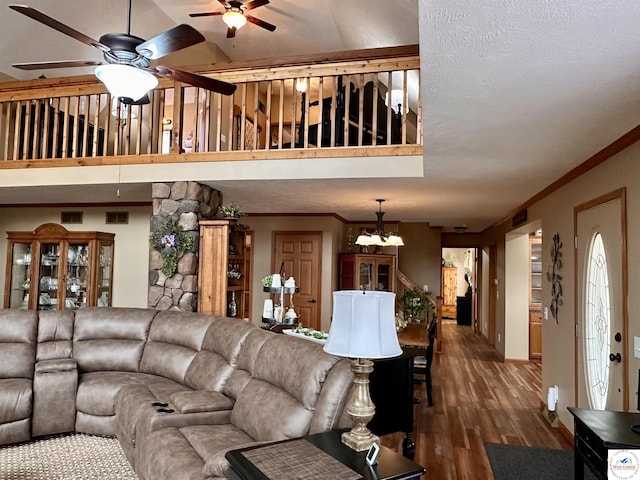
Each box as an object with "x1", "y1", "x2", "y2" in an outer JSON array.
[{"x1": 147, "y1": 182, "x2": 222, "y2": 312}]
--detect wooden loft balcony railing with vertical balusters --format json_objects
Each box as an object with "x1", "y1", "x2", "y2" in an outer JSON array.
[{"x1": 0, "y1": 46, "x2": 422, "y2": 168}]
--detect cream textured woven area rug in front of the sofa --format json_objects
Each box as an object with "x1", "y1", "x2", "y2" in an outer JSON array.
[{"x1": 0, "y1": 434, "x2": 138, "y2": 480}]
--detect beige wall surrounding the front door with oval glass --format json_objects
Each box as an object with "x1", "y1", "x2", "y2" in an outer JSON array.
[{"x1": 487, "y1": 139, "x2": 640, "y2": 431}]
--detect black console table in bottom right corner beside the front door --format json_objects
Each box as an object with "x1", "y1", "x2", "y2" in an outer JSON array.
[{"x1": 568, "y1": 407, "x2": 640, "y2": 480}]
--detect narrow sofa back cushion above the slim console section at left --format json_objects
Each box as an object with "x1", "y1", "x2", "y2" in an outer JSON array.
[{"x1": 36, "y1": 310, "x2": 75, "y2": 361}]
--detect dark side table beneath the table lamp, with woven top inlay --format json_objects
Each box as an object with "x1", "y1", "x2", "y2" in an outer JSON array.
[{"x1": 226, "y1": 430, "x2": 425, "y2": 480}]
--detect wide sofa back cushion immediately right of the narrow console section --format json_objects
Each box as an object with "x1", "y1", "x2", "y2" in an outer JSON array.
[{"x1": 73, "y1": 307, "x2": 158, "y2": 372}]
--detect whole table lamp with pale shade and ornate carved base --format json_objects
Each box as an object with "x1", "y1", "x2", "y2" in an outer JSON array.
[{"x1": 324, "y1": 290, "x2": 402, "y2": 452}]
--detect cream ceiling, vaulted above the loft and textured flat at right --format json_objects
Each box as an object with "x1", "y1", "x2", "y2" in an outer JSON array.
[{"x1": 0, "y1": 0, "x2": 640, "y2": 231}]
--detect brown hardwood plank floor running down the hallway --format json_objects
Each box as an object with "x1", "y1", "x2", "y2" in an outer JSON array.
[{"x1": 382, "y1": 320, "x2": 573, "y2": 480}]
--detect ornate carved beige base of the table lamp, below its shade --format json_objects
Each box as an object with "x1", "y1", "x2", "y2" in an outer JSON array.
[{"x1": 342, "y1": 359, "x2": 380, "y2": 452}]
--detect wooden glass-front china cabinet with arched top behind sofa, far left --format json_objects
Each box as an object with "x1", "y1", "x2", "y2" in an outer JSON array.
[{"x1": 4, "y1": 223, "x2": 115, "y2": 310}]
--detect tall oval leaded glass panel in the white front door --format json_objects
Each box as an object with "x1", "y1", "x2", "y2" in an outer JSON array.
[{"x1": 583, "y1": 232, "x2": 611, "y2": 410}]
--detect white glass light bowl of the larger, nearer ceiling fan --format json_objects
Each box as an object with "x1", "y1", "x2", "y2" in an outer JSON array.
[{"x1": 95, "y1": 64, "x2": 158, "y2": 102}]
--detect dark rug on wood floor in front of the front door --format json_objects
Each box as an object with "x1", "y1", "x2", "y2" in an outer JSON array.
[{"x1": 484, "y1": 443, "x2": 596, "y2": 480}]
